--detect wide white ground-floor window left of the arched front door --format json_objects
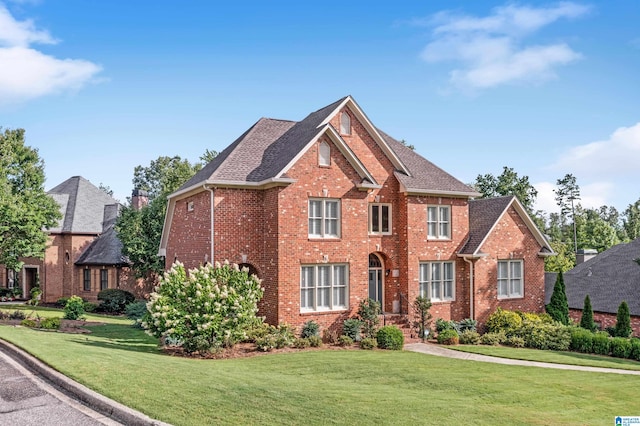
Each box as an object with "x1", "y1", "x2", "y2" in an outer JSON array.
[{"x1": 300, "y1": 264, "x2": 349, "y2": 312}]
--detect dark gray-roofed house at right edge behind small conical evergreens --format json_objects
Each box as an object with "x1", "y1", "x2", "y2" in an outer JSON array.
[{"x1": 546, "y1": 238, "x2": 640, "y2": 337}]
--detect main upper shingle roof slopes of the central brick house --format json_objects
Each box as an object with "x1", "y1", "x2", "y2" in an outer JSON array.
[{"x1": 176, "y1": 96, "x2": 477, "y2": 196}]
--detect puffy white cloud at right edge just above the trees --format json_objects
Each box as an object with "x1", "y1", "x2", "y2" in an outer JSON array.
[{"x1": 552, "y1": 123, "x2": 640, "y2": 177}]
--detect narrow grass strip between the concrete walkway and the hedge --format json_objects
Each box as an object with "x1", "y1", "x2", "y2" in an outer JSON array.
[{"x1": 449, "y1": 345, "x2": 640, "y2": 371}]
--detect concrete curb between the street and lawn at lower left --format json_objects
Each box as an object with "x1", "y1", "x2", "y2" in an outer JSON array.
[{"x1": 0, "y1": 339, "x2": 171, "y2": 426}]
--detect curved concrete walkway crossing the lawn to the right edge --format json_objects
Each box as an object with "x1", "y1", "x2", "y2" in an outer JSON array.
[{"x1": 404, "y1": 343, "x2": 640, "y2": 376}]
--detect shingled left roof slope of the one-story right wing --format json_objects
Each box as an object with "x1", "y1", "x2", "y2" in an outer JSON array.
[{"x1": 460, "y1": 195, "x2": 515, "y2": 254}]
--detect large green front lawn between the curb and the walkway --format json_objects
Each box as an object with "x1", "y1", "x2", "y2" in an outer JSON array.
[{"x1": 0, "y1": 318, "x2": 640, "y2": 425}]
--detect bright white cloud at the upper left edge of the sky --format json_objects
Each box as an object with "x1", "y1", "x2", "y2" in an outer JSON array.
[{"x1": 0, "y1": 4, "x2": 101, "y2": 104}]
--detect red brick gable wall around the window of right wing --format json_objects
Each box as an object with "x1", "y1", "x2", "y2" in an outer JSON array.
[{"x1": 474, "y1": 208, "x2": 544, "y2": 323}]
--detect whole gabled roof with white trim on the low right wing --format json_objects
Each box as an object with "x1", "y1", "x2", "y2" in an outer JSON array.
[{"x1": 459, "y1": 195, "x2": 553, "y2": 256}]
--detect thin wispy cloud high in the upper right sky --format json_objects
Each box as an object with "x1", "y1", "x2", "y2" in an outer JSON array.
[{"x1": 420, "y1": 2, "x2": 589, "y2": 89}]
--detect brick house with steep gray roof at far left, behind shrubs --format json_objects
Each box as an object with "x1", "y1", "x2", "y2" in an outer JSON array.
[{"x1": 0, "y1": 176, "x2": 144, "y2": 303}]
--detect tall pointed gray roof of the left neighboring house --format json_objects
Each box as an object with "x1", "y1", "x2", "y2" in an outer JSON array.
[{"x1": 47, "y1": 176, "x2": 118, "y2": 234}]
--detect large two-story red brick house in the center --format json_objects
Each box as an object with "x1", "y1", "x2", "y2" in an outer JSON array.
[{"x1": 159, "y1": 96, "x2": 552, "y2": 328}]
